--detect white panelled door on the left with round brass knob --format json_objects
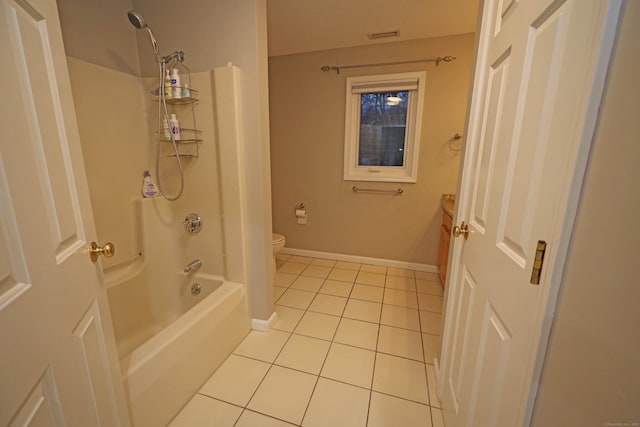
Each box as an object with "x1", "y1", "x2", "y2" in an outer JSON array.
[{"x1": 0, "y1": 0, "x2": 128, "y2": 426}]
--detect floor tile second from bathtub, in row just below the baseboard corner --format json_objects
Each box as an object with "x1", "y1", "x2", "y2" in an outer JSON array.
[{"x1": 276, "y1": 334, "x2": 331, "y2": 374}]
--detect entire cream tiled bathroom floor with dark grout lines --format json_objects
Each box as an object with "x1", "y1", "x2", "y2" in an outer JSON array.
[{"x1": 171, "y1": 255, "x2": 444, "y2": 427}]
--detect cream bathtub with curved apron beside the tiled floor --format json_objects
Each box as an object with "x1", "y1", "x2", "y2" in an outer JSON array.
[{"x1": 105, "y1": 268, "x2": 250, "y2": 426}]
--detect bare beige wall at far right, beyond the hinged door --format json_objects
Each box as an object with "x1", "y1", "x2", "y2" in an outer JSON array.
[{"x1": 532, "y1": 1, "x2": 640, "y2": 427}]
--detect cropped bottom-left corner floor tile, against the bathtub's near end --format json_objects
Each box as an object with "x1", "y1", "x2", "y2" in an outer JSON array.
[{"x1": 169, "y1": 394, "x2": 242, "y2": 427}]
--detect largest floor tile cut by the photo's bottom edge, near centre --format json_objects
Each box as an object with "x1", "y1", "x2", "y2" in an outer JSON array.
[{"x1": 302, "y1": 378, "x2": 369, "y2": 427}]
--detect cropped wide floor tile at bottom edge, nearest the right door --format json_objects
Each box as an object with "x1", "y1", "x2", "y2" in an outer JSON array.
[{"x1": 367, "y1": 391, "x2": 431, "y2": 427}]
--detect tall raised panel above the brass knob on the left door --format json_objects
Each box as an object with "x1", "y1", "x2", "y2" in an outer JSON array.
[{"x1": 8, "y1": 2, "x2": 84, "y2": 262}]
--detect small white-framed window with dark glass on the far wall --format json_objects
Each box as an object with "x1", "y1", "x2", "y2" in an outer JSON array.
[{"x1": 344, "y1": 72, "x2": 426, "y2": 182}]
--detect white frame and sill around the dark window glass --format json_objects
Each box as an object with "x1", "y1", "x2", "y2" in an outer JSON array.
[{"x1": 344, "y1": 71, "x2": 427, "y2": 183}]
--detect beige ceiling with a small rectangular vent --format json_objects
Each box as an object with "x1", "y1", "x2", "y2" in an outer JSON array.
[{"x1": 267, "y1": 0, "x2": 479, "y2": 56}]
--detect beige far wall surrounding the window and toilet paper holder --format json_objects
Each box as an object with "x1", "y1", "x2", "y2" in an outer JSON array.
[{"x1": 269, "y1": 34, "x2": 474, "y2": 265}]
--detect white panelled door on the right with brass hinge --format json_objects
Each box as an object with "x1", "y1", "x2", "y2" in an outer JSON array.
[{"x1": 439, "y1": 0, "x2": 620, "y2": 427}]
